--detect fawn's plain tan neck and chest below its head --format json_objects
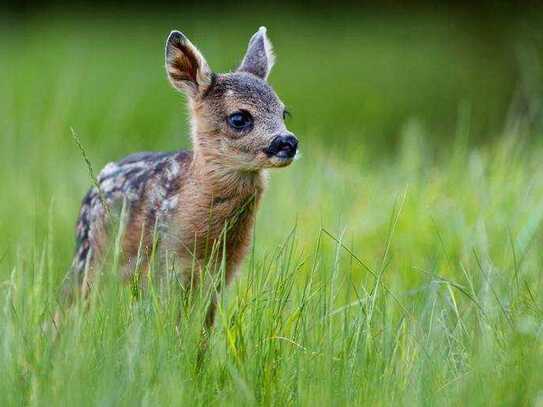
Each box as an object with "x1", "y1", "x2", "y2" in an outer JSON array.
[{"x1": 172, "y1": 149, "x2": 265, "y2": 264}]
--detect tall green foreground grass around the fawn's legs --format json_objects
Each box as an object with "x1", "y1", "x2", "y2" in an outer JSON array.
[{"x1": 4, "y1": 130, "x2": 543, "y2": 405}]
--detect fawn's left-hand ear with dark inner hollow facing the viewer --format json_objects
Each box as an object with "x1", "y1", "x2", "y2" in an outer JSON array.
[{"x1": 166, "y1": 31, "x2": 212, "y2": 97}]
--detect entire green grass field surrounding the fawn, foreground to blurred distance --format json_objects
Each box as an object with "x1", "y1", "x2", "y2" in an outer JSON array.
[{"x1": 0, "y1": 7, "x2": 543, "y2": 406}]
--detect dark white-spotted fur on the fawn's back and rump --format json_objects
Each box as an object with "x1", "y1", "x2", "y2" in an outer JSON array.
[{"x1": 72, "y1": 151, "x2": 191, "y2": 280}]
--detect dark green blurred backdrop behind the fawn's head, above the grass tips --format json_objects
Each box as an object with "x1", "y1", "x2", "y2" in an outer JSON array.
[{"x1": 4, "y1": 1, "x2": 543, "y2": 153}]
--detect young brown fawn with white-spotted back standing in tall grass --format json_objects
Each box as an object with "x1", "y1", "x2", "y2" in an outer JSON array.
[{"x1": 68, "y1": 27, "x2": 298, "y2": 325}]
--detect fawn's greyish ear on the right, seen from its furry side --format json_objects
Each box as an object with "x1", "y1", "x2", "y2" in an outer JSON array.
[{"x1": 238, "y1": 27, "x2": 275, "y2": 80}]
